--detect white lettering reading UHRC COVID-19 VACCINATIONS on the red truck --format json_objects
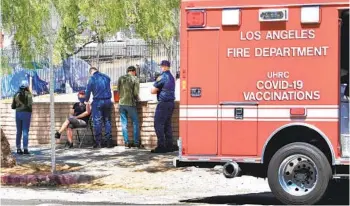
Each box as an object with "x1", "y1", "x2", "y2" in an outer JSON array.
[{"x1": 243, "y1": 72, "x2": 321, "y2": 101}]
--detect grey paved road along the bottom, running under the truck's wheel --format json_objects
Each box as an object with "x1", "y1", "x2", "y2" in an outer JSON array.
[{"x1": 0, "y1": 181, "x2": 349, "y2": 206}]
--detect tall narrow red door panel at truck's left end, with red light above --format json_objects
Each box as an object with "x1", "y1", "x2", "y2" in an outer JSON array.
[{"x1": 181, "y1": 10, "x2": 220, "y2": 156}]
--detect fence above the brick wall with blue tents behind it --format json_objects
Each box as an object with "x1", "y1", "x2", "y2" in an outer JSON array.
[{"x1": 0, "y1": 40, "x2": 180, "y2": 98}]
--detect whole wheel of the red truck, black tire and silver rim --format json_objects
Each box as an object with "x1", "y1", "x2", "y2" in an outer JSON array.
[{"x1": 267, "y1": 142, "x2": 332, "y2": 205}]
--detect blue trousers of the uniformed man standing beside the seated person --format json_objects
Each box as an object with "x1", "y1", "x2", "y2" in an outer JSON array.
[{"x1": 92, "y1": 99, "x2": 112, "y2": 144}]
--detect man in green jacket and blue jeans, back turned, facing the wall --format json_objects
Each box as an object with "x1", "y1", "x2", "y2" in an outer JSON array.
[{"x1": 118, "y1": 66, "x2": 141, "y2": 148}]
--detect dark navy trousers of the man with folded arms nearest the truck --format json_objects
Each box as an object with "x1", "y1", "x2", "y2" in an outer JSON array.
[{"x1": 154, "y1": 102, "x2": 175, "y2": 147}]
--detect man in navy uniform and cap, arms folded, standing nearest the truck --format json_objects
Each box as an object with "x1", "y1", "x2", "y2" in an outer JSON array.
[{"x1": 151, "y1": 60, "x2": 175, "y2": 153}]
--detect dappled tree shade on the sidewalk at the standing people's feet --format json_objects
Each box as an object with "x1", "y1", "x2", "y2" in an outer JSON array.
[{"x1": 12, "y1": 145, "x2": 185, "y2": 173}]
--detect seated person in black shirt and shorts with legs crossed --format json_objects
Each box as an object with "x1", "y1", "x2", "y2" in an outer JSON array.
[{"x1": 55, "y1": 91, "x2": 91, "y2": 148}]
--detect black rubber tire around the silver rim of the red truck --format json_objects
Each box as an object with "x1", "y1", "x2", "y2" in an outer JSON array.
[{"x1": 267, "y1": 142, "x2": 332, "y2": 205}]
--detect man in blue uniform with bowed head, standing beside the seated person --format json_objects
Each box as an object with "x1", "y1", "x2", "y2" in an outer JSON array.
[{"x1": 85, "y1": 67, "x2": 114, "y2": 148}]
